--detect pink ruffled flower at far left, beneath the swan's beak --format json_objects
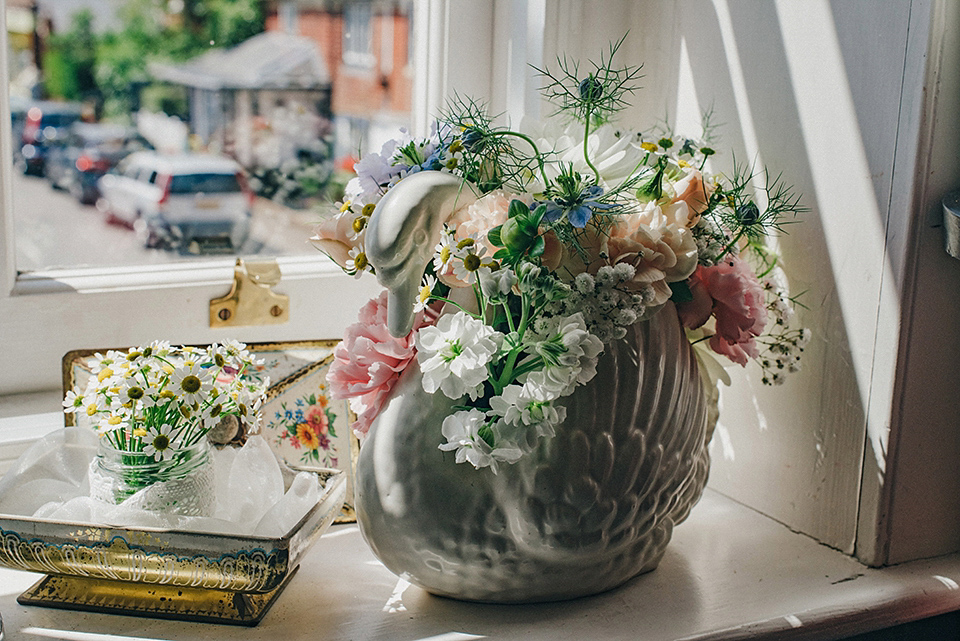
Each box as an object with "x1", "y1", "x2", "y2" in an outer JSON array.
[{"x1": 327, "y1": 292, "x2": 433, "y2": 435}]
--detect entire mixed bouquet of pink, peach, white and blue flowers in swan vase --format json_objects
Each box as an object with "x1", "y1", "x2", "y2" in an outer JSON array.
[{"x1": 312, "y1": 41, "x2": 808, "y2": 471}]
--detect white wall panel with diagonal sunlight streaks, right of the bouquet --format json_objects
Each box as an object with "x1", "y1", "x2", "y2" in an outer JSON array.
[{"x1": 633, "y1": 0, "x2": 928, "y2": 553}]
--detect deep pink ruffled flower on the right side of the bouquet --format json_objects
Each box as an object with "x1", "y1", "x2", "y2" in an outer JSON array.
[{"x1": 677, "y1": 256, "x2": 767, "y2": 365}]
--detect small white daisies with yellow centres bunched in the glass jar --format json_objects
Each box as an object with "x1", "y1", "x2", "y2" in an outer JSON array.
[{"x1": 63, "y1": 341, "x2": 269, "y2": 462}]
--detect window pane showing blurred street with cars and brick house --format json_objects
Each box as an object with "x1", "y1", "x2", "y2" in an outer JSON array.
[{"x1": 7, "y1": 0, "x2": 413, "y2": 272}]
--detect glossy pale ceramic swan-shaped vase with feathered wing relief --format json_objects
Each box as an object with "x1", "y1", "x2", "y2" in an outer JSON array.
[{"x1": 356, "y1": 172, "x2": 709, "y2": 603}]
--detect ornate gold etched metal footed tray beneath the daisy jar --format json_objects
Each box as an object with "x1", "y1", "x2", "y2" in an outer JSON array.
[{"x1": 0, "y1": 469, "x2": 346, "y2": 626}]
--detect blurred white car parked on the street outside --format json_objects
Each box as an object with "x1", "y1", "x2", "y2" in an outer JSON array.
[{"x1": 98, "y1": 152, "x2": 254, "y2": 250}]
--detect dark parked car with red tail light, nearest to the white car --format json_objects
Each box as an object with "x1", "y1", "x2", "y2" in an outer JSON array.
[{"x1": 46, "y1": 122, "x2": 152, "y2": 205}]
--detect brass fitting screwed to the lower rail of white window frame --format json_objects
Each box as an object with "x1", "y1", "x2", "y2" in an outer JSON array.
[{"x1": 210, "y1": 258, "x2": 290, "y2": 328}]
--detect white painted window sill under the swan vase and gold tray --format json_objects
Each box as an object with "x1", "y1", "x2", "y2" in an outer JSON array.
[{"x1": 0, "y1": 400, "x2": 960, "y2": 641}]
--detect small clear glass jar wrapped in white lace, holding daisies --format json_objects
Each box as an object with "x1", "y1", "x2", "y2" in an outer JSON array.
[{"x1": 89, "y1": 438, "x2": 214, "y2": 516}]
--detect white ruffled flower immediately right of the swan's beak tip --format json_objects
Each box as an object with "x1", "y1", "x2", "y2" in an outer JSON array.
[{"x1": 416, "y1": 312, "x2": 503, "y2": 399}]
